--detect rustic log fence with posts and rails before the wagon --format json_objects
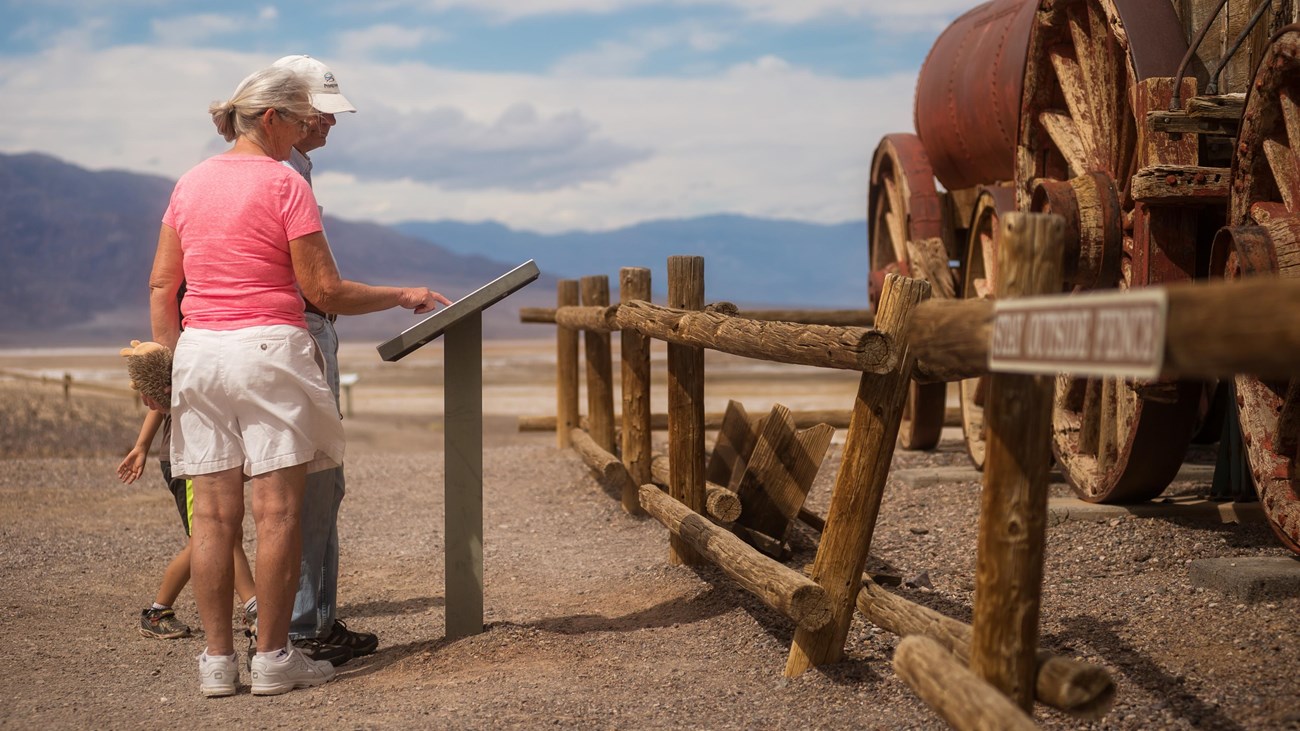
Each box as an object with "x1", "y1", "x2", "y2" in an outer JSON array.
[{"x1": 521, "y1": 213, "x2": 1300, "y2": 727}]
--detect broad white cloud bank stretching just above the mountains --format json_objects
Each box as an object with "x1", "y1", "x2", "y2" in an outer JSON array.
[{"x1": 0, "y1": 36, "x2": 915, "y2": 230}]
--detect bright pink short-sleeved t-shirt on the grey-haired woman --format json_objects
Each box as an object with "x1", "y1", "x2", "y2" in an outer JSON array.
[{"x1": 163, "y1": 155, "x2": 321, "y2": 330}]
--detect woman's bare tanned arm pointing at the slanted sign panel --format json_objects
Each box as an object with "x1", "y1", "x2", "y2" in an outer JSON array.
[{"x1": 289, "y1": 232, "x2": 451, "y2": 314}]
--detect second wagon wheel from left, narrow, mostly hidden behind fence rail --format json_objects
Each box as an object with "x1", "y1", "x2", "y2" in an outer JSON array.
[{"x1": 958, "y1": 186, "x2": 1015, "y2": 470}]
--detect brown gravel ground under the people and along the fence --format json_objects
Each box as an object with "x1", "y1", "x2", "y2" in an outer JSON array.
[{"x1": 0, "y1": 374, "x2": 1300, "y2": 730}]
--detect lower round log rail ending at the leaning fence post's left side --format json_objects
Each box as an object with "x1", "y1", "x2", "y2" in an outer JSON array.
[{"x1": 641, "y1": 485, "x2": 831, "y2": 630}]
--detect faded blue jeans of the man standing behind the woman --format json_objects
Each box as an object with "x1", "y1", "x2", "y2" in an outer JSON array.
[{"x1": 289, "y1": 312, "x2": 345, "y2": 640}]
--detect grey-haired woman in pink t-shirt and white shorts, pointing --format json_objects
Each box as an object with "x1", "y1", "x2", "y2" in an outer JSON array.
[{"x1": 150, "y1": 68, "x2": 450, "y2": 696}]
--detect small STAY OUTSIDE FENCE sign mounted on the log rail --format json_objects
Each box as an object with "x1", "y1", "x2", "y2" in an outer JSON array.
[{"x1": 988, "y1": 287, "x2": 1169, "y2": 379}]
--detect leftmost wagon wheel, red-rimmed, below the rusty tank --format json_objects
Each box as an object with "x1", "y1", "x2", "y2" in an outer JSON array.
[{"x1": 867, "y1": 134, "x2": 950, "y2": 449}]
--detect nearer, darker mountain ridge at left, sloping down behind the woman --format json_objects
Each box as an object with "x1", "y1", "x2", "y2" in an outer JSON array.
[{"x1": 0, "y1": 155, "x2": 555, "y2": 347}]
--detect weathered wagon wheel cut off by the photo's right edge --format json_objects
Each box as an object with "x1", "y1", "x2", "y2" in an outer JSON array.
[{"x1": 1216, "y1": 26, "x2": 1300, "y2": 553}]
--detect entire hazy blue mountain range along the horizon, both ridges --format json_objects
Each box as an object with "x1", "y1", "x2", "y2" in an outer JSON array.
[{"x1": 0, "y1": 153, "x2": 867, "y2": 347}]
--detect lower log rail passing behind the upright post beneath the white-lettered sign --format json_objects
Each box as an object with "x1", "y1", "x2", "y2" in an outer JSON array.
[{"x1": 858, "y1": 578, "x2": 1115, "y2": 721}]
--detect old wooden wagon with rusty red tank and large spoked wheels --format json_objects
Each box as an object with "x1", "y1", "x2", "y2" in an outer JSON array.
[{"x1": 867, "y1": 0, "x2": 1300, "y2": 553}]
